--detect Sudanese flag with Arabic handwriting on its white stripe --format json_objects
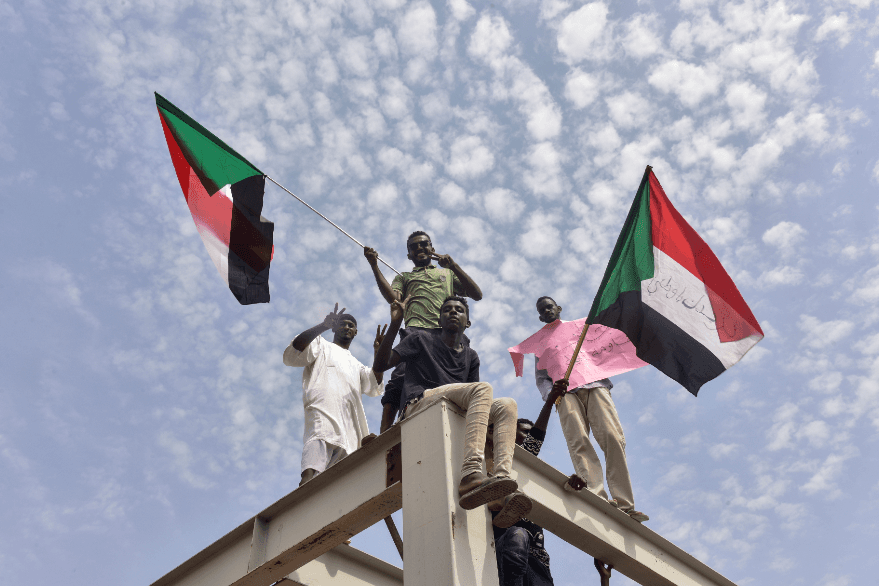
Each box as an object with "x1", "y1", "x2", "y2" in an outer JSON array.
[{"x1": 587, "y1": 167, "x2": 763, "y2": 395}]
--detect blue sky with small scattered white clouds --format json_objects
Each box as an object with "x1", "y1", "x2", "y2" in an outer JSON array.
[{"x1": 0, "y1": 0, "x2": 879, "y2": 586}]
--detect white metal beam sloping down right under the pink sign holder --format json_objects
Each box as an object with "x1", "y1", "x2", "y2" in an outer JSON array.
[{"x1": 512, "y1": 447, "x2": 735, "y2": 586}]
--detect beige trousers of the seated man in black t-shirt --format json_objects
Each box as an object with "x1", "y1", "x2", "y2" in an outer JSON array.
[{"x1": 404, "y1": 382, "x2": 519, "y2": 478}]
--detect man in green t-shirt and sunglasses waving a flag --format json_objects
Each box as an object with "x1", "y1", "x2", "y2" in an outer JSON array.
[{"x1": 363, "y1": 230, "x2": 482, "y2": 431}]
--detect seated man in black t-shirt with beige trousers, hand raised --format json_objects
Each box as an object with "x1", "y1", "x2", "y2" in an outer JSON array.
[{"x1": 373, "y1": 296, "x2": 531, "y2": 518}]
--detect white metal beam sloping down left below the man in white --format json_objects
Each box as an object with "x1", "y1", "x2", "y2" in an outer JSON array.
[{"x1": 153, "y1": 427, "x2": 403, "y2": 586}]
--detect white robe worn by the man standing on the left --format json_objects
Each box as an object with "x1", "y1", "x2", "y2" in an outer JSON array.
[{"x1": 284, "y1": 336, "x2": 383, "y2": 454}]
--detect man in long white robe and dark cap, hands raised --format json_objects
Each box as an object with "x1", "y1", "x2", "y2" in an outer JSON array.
[{"x1": 284, "y1": 303, "x2": 387, "y2": 486}]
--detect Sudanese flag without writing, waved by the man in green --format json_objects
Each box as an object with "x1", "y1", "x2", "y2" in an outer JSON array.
[{"x1": 156, "y1": 93, "x2": 274, "y2": 305}]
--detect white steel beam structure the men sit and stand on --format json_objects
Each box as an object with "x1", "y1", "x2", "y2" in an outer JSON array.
[{"x1": 152, "y1": 401, "x2": 735, "y2": 586}]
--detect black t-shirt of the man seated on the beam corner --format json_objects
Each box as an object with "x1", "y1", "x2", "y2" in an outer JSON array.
[{"x1": 391, "y1": 330, "x2": 479, "y2": 408}]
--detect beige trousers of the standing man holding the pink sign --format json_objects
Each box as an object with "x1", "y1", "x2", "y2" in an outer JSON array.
[{"x1": 558, "y1": 387, "x2": 635, "y2": 509}]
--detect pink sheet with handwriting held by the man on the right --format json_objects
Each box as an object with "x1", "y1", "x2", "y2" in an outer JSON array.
[{"x1": 509, "y1": 317, "x2": 647, "y2": 390}]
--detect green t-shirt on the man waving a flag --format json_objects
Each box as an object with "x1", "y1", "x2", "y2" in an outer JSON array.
[{"x1": 391, "y1": 265, "x2": 463, "y2": 328}]
